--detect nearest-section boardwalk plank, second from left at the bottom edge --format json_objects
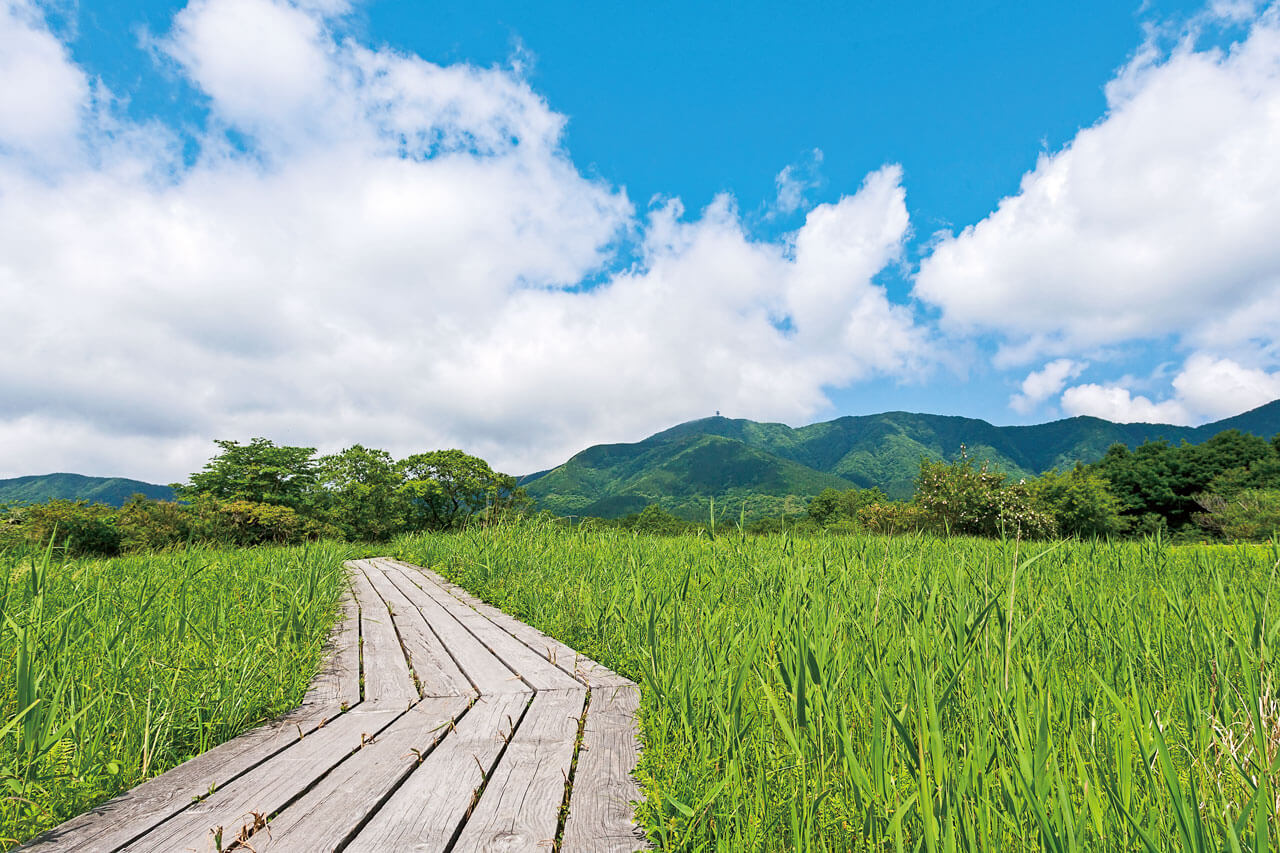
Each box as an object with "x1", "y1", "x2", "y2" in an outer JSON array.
[{"x1": 128, "y1": 703, "x2": 406, "y2": 853}]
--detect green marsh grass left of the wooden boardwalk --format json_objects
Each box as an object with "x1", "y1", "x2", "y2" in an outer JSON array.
[{"x1": 0, "y1": 544, "x2": 348, "y2": 849}]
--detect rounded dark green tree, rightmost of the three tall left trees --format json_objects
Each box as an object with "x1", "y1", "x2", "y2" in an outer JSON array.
[{"x1": 397, "y1": 450, "x2": 529, "y2": 530}]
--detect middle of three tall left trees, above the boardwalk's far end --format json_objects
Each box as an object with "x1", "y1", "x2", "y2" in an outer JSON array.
[{"x1": 316, "y1": 444, "x2": 404, "y2": 542}]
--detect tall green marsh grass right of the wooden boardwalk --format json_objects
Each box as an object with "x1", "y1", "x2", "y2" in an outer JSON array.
[{"x1": 393, "y1": 525, "x2": 1280, "y2": 853}]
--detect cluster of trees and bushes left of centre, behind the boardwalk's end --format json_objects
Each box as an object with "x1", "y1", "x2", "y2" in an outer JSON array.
[{"x1": 0, "y1": 438, "x2": 529, "y2": 556}]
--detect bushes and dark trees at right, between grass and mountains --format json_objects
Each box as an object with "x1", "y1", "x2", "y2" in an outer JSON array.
[{"x1": 799, "y1": 429, "x2": 1280, "y2": 540}]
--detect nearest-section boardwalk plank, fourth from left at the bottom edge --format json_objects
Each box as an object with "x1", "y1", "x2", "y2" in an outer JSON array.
[{"x1": 346, "y1": 693, "x2": 531, "y2": 853}]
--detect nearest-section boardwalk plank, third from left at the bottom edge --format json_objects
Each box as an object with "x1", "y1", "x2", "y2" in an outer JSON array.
[{"x1": 241, "y1": 695, "x2": 471, "y2": 853}]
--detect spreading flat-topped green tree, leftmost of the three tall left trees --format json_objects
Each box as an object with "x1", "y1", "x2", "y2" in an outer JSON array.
[{"x1": 173, "y1": 438, "x2": 317, "y2": 510}]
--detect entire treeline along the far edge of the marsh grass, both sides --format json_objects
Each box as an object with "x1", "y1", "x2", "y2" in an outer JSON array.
[{"x1": 0, "y1": 429, "x2": 1280, "y2": 556}]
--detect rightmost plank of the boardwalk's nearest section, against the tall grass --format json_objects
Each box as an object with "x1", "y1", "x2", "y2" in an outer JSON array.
[{"x1": 561, "y1": 685, "x2": 649, "y2": 853}]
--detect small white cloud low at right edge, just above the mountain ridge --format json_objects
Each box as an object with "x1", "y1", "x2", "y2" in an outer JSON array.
[{"x1": 1062, "y1": 353, "x2": 1280, "y2": 424}]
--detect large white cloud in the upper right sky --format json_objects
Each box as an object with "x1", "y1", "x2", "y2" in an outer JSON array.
[{"x1": 915, "y1": 3, "x2": 1280, "y2": 361}]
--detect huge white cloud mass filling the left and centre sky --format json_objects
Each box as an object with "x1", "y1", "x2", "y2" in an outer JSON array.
[{"x1": 0, "y1": 0, "x2": 929, "y2": 482}]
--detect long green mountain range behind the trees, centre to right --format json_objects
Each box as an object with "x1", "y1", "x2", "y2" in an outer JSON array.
[{"x1": 520, "y1": 400, "x2": 1280, "y2": 517}]
